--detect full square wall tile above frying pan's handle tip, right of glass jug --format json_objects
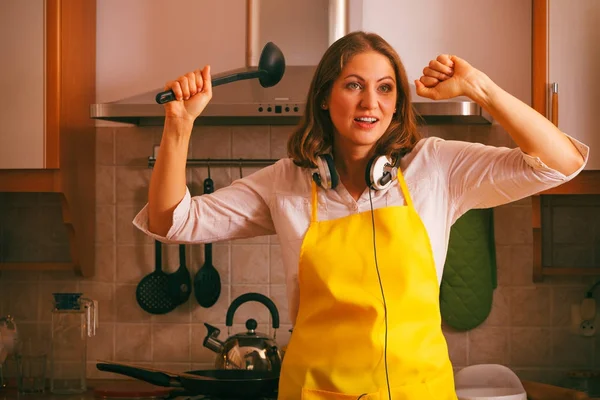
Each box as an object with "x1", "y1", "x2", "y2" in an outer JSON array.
[{"x1": 115, "y1": 323, "x2": 152, "y2": 363}]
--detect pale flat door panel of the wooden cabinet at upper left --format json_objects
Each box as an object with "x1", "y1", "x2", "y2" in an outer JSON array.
[{"x1": 0, "y1": 0, "x2": 45, "y2": 169}]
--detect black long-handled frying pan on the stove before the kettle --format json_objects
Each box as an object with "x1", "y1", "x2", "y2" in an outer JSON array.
[{"x1": 96, "y1": 362, "x2": 279, "y2": 399}]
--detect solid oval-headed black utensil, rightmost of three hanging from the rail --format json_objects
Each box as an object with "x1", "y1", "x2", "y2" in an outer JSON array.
[{"x1": 194, "y1": 176, "x2": 221, "y2": 308}]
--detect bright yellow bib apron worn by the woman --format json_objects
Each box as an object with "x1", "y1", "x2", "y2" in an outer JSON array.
[{"x1": 278, "y1": 171, "x2": 456, "y2": 400}]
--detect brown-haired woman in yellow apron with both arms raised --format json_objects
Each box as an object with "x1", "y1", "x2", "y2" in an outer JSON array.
[{"x1": 135, "y1": 32, "x2": 588, "y2": 400}]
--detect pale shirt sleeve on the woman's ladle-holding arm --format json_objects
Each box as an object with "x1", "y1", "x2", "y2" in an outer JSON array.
[{"x1": 133, "y1": 160, "x2": 277, "y2": 243}]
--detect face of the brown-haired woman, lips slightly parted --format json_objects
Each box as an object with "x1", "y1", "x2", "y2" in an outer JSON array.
[{"x1": 325, "y1": 51, "x2": 397, "y2": 150}]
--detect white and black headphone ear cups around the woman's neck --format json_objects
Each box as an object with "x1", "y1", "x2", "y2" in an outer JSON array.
[{"x1": 312, "y1": 154, "x2": 400, "y2": 190}]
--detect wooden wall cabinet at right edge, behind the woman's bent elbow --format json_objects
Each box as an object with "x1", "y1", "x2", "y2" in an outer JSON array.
[{"x1": 532, "y1": 0, "x2": 600, "y2": 281}]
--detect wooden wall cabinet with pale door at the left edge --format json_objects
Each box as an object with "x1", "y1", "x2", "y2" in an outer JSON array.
[{"x1": 0, "y1": 0, "x2": 96, "y2": 276}]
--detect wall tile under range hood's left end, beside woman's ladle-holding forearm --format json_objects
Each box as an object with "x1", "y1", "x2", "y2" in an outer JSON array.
[{"x1": 115, "y1": 127, "x2": 162, "y2": 166}]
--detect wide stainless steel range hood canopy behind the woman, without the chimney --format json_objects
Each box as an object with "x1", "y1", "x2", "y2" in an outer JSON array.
[{"x1": 91, "y1": 66, "x2": 491, "y2": 126}]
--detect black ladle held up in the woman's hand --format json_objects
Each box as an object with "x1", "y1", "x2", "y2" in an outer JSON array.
[{"x1": 156, "y1": 42, "x2": 285, "y2": 104}]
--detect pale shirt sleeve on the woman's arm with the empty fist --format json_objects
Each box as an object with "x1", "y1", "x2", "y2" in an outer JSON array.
[{"x1": 434, "y1": 136, "x2": 589, "y2": 222}]
